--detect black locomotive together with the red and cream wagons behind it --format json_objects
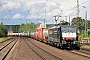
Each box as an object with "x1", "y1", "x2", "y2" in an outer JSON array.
[{"x1": 30, "y1": 25, "x2": 80, "y2": 50}]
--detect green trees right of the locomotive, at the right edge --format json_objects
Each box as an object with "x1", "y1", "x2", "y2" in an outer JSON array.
[{"x1": 71, "y1": 17, "x2": 90, "y2": 38}]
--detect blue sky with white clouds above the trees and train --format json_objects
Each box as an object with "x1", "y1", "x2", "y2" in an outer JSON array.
[{"x1": 0, "y1": 0, "x2": 90, "y2": 25}]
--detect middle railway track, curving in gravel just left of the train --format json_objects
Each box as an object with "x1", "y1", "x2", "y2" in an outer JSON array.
[{"x1": 24, "y1": 39, "x2": 62, "y2": 60}]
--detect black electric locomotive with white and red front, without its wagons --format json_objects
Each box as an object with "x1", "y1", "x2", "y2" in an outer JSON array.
[{"x1": 48, "y1": 25, "x2": 80, "y2": 50}]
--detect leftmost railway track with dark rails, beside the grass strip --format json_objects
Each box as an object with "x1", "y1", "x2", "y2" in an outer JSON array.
[{"x1": 0, "y1": 38, "x2": 18, "y2": 60}]
